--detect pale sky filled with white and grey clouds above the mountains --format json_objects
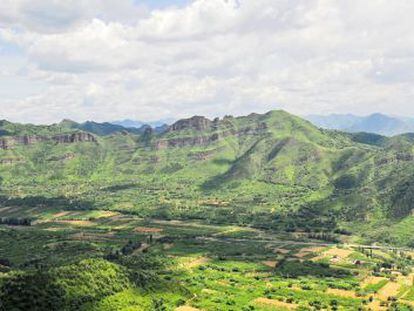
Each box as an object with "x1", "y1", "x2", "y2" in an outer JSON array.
[{"x1": 0, "y1": 0, "x2": 414, "y2": 123}]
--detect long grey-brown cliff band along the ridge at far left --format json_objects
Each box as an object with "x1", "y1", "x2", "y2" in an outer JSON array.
[{"x1": 0, "y1": 132, "x2": 97, "y2": 150}]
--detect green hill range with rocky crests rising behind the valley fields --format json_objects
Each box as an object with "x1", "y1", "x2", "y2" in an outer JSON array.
[{"x1": 0, "y1": 111, "x2": 414, "y2": 245}]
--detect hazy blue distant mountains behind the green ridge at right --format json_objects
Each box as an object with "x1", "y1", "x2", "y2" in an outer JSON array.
[{"x1": 305, "y1": 113, "x2": 414, "y2": 136}]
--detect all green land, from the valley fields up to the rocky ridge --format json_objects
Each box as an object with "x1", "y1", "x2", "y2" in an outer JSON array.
[{"x1": 0, "y1": 111, "x2": 414, "y2": 311}]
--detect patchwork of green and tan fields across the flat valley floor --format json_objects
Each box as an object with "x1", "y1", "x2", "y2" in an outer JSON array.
[{"x1": 0, "y1": 209, "x2": 414, "y2": 311}]
